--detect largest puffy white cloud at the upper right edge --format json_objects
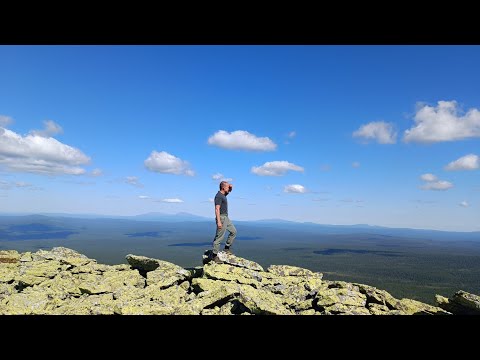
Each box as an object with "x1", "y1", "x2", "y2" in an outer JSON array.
[{"x1": 404, "y1": 101, "x2": 480, "y2": 143}]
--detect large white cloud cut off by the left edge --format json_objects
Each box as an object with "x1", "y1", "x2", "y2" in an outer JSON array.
[{"x1": 0, "y1": 128, "x2": 90, "y2": 175}]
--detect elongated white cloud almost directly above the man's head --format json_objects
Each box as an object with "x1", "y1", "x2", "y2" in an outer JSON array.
[{"x1": 208, "y1": 130, "x2": 277, "y2": 151}]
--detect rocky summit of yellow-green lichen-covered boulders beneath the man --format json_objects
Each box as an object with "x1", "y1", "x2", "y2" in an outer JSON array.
[{"x1": 0, "y1": 247, "x2": 480, "y2": 315}]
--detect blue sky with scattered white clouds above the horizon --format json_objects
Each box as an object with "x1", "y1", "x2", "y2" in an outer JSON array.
[{"x1": 0, "y1": 45, "x2": 480, "y2": 231}]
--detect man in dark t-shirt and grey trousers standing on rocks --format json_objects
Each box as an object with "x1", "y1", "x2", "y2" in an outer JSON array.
[{"x1": 212, "y1": 181, "x2": 237, "y2": 264}]
